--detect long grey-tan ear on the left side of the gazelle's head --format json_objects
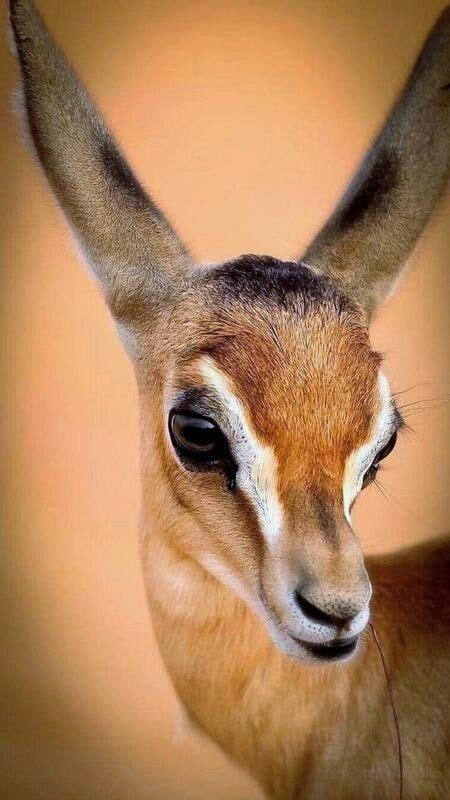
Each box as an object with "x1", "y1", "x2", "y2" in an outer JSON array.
[{"x1": 10, "y1": 0, "x2": 192, "y2": 323}]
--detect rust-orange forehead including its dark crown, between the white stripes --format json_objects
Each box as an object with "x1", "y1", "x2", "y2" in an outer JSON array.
[{"x1": 174, "y1": 255, "x2": 380, "y2": 476}]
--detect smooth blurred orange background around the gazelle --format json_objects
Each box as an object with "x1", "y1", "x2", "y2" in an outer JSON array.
[{"x1": 0, "y1": 0, "x2": 450, "y2": 800}]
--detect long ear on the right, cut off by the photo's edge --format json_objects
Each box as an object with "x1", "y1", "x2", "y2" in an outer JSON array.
[{"x1": 302, "y1": 6, "x2": 450, "y2": 315}]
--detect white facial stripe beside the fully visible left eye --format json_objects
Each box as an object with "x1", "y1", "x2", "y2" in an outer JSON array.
[{"x1": 199, "y1": 356, "x2": 283, "y2": 544}]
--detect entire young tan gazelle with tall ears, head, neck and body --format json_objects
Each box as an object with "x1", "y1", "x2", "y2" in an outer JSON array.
[{"x1": 11, "y1": 0, "x2": 450, "y2": 800}]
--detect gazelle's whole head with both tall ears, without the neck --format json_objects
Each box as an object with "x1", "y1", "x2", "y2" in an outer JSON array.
[{"x1": 11, "y1": 0, "x2": 450, "y2": 661}]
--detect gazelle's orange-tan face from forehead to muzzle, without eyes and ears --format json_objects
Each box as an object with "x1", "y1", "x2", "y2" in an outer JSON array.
[{"x1": 143, "y1": 277, "x2": 384, "y2": 659}]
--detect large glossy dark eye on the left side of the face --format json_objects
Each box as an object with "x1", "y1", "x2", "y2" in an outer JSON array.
[{"x1": 169, "y1": 411, "x2": 228, "y2": 464}]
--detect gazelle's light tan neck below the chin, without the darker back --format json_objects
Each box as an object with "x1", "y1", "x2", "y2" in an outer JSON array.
[{"x1": 144, "y1": 529, "x2": 396, "y2": 800}]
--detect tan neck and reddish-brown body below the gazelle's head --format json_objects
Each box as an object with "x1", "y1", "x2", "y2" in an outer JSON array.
[{"x1": 144, "y1": 528, "x2": 450, "y2": 800}]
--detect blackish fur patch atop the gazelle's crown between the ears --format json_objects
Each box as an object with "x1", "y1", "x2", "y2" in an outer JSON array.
[{"x1": 208, "y1": 254, "x2": 352, "y2": 313}]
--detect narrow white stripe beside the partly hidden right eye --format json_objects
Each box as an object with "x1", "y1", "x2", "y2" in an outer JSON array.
[{"x1": 343, "y1": 372, "x2": 395, "y2": 522}]
